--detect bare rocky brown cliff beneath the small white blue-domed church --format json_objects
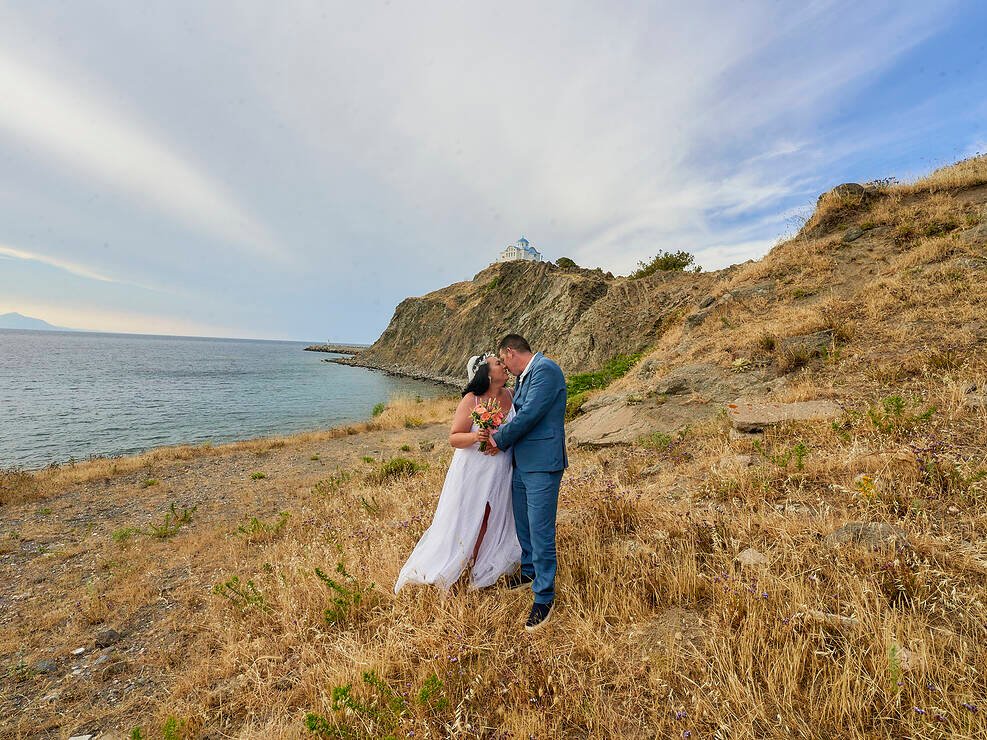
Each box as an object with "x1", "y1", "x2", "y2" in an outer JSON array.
[{"x1": 346, "y1": 262, "x2": 723, "y2": 385}]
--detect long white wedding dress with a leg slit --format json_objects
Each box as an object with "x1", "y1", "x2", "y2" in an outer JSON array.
[{"x1": 394, "y1": 406, "x2": 521, "y2": 593}]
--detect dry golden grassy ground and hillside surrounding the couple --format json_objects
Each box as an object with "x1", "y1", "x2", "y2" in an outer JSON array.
[{"x1": 0, "y1": 160, "x2": 987, "y2": 738}]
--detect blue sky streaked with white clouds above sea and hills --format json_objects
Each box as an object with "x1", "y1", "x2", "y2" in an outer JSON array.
[{"x1": 0, "y1": 0, "x2": 987, "y2": 341}]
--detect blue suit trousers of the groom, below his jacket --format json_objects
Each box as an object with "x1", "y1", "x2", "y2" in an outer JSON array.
[{"x1": 511, "y1": 468, "x2": 562, "y2": 604}]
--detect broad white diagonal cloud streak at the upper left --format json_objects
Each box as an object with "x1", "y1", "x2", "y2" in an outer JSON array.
[{"x1": 0, "y1": 48, "x2": 278, "y2": 256}]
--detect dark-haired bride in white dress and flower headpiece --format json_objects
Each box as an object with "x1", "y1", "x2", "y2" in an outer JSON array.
[{"x1": 394, "y1": 355, "x2": 521, "y2": 593}]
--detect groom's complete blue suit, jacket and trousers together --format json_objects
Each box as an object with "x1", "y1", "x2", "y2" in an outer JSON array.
[{"x1": 493, "y1": 352, "x2": 569, "y2": 604}]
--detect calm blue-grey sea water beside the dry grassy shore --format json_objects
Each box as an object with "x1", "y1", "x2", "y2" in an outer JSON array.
[{"x1": 0, "y1": 329, "x2": 448, "y2": 468}]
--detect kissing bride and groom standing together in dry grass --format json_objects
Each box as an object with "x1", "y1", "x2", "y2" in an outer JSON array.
[{"x1": 394, "y1": 334, "x2": 569, "y2": 632}]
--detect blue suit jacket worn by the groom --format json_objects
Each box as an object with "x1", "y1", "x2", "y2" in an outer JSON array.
[{"x1": 493, "y1": 352, "x2": 569, "y2": 473}]
